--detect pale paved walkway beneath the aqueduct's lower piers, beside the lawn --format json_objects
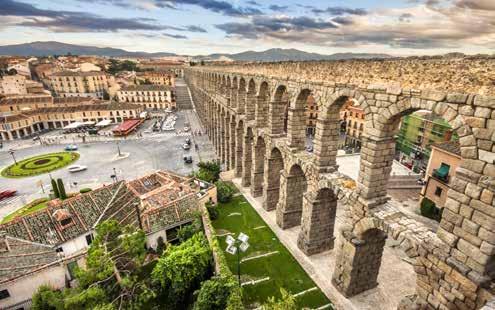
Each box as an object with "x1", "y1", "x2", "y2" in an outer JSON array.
[{"x1": 233, "y1": 179, "x2": 415, "y2": 310}]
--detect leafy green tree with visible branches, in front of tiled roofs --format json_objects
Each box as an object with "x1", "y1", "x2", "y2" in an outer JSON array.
[{"x1": 66, "y1": 220, "x2": 155, "y2": 309}]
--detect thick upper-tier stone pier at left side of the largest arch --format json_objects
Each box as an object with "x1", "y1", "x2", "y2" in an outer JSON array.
[{"x1": 358, "y1": 137, "x2": 395, "y2": 205}]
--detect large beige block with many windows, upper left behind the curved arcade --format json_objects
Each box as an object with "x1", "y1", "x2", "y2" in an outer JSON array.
[{"x1": 50, "y1": 71, "x2": 113, "y2": 99}]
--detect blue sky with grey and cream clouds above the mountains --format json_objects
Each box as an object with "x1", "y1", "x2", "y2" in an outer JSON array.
[{"x1": 0, "y1": 0, "x2": 495, "y2": 56}]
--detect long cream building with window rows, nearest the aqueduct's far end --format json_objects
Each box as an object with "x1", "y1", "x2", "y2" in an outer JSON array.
[{"x1": 117, "y1": 85, "x2": 176, "y2": 109}]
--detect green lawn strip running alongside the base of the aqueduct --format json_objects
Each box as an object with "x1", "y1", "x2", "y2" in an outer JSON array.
[{"x1": 213, "y1": 195, "x2": 331, "y2": 309}]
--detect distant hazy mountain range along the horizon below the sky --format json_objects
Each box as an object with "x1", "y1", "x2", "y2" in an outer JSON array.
[{"x1": 0, "y1": 41, "x2": 392, "y2": 61}]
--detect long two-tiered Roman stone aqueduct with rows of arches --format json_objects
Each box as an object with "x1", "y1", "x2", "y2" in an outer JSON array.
[{"x1": 185, "y1": 57, "x2": 495, "y2": 309}]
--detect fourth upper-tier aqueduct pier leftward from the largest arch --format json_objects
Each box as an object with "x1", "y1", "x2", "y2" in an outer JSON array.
[{"x1": 268, "y1": 85, "x2": 290, "y2": 136}]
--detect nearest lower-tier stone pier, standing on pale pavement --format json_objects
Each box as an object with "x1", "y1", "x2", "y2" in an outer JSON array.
[{"x1": 332, "y1": 230, "x2": 387, "y2": 297}]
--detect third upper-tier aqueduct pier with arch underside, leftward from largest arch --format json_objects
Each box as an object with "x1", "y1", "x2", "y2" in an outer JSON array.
[{"x1": 286, "y1": 88, "x2": 311, "y2": 151}]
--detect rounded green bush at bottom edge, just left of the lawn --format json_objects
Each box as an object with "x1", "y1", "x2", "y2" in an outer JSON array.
[{"x1": 193, "y1": 277, "x2": 234, "y2": 310}]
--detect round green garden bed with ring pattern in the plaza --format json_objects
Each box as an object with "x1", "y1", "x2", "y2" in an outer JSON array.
[{"x1": 2, "y1": 152, "x2": 79, "y2": 178}]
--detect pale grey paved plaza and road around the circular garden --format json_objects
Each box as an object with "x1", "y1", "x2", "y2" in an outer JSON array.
[{"x1": 0, "y1": 110, "x2": 215, "y2": 218}]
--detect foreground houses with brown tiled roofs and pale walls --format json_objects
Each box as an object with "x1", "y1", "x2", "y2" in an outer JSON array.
[{"x1": 0, "y1": 171, "x2": 216, "y2": 309}]
